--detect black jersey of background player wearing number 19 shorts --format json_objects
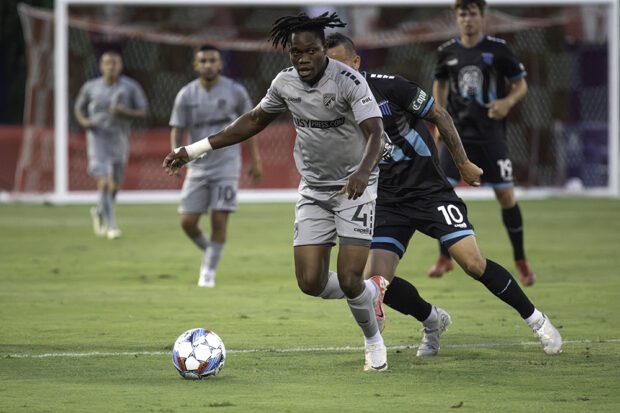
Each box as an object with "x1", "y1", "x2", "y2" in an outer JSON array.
[{"x1": 435, "y1": 36, "x2": 527, "y2": 142}]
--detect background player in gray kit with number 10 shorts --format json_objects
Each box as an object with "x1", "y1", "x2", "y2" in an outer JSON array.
[{"x1": 170, "y1": 45, "x2": 262, "y2": 287}]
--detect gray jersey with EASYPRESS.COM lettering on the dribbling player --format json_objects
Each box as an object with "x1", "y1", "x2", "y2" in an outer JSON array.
[{"x1": 260, "y1": 59, "x2": 381, "y2": 189}]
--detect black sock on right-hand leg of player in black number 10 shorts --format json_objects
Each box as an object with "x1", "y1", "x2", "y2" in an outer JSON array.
[{"x1": 478, "y1": 260, "x2": 534, "y2": 318}]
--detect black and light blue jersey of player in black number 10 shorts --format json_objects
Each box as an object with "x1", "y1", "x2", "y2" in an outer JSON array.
[{"x1": 362, "y1": 72, "x2": 452, "y2": 205}]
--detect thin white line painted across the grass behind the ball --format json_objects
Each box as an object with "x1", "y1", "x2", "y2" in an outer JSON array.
[{"x1": 0, "y1": 338, "x2": 620, "y2": 359}]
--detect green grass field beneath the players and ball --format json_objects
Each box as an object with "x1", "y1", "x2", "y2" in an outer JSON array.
[{"x1": 0, "y1": 199, "x2": 620, "y2": 413}]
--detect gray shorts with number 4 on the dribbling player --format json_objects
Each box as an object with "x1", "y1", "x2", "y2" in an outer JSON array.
[{"x1": 293, "y1": 195, "x2": 375, "y2": 246}]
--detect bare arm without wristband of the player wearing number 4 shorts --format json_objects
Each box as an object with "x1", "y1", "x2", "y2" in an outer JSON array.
[{"x1": 340, "y1": 118, "x2": 384, "y2": 199}]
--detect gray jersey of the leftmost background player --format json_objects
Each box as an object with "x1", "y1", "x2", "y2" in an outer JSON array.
[{"x1": 75, "y1": 76, "x2": 148, "y2": 162}]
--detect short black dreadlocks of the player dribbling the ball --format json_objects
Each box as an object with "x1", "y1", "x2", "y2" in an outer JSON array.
[{"x1": 269, "y1": 12, "x2": 347, "y2": 48}]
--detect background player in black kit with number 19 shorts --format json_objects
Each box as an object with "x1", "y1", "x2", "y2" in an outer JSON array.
[{"x1": 428, "y1": 0, "x2": 535, "y2": 286}]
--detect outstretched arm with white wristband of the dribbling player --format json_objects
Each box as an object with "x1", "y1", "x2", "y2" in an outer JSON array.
[{"x1": 162, "y1": 105, "x2": 278, "y2": 175}]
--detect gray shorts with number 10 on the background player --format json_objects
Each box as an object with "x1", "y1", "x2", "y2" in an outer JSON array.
[{"x1": 179, "y1": 177, "x2": 239, "y2": 214}]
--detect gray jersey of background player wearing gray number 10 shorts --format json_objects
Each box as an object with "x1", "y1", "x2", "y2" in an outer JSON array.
[{"x1": 170, "y1": 76, "x2": 252, "y2": 178}]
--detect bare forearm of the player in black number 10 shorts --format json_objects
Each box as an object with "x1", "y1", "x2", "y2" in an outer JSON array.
[{"x1": 425, "y1": 105, "x2": 482, "y2": 186}]
